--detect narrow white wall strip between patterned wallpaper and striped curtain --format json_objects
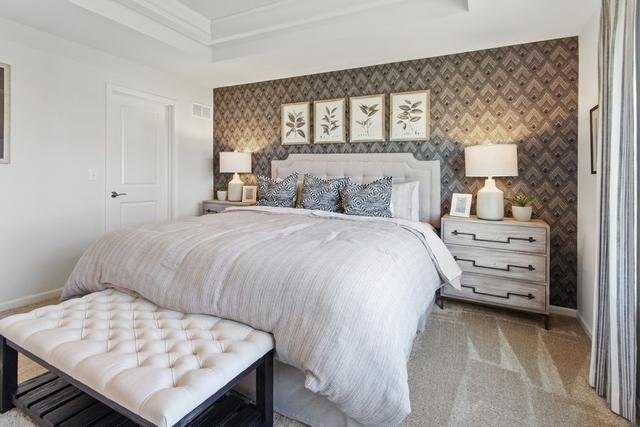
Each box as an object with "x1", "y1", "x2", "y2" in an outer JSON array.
[{"x1": 578, "y1": 11, "x2": 600, "y2": 333}]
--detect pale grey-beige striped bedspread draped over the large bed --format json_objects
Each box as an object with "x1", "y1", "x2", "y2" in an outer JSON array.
[{"x1": 63, "y1": 207, "x2": 461, "y2": 426}]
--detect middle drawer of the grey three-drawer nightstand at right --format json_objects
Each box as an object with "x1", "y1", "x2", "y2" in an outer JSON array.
[{"x1": 449, "y1": 246, "x2": 547, "y2": 282}]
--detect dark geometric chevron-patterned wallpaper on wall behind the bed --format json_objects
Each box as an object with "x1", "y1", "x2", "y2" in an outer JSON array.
[{"x1": 214, "y1": 37, "x2": 578, "y2": 308}]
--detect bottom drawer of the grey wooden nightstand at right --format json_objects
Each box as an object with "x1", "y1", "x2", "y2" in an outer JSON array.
[{"x1": 442, "y1": 273, "x2": 547, "y2": 313}]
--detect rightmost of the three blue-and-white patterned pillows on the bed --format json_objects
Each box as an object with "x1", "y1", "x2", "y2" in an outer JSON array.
[{"x1": 340, "y1": 176, "x2": 393, "y2": 218}]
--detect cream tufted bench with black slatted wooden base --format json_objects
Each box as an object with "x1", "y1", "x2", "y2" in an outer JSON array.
[{"x1": 0, "y1": 290, "x2": 273, "y2": 426}]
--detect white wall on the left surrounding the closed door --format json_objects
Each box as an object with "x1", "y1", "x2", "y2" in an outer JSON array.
[{"x1": 0, "y1": 19, "x2": 213, "y2": 310}]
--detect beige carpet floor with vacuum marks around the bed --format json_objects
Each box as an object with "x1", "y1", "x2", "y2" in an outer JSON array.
[{"x1": 0, "y1": 302, "x2": 629, "y2": 427}]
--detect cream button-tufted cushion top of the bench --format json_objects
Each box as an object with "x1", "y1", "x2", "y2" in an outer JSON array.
[{"x1": 0, "y1": 290, "x2": 273, "y2": 426}]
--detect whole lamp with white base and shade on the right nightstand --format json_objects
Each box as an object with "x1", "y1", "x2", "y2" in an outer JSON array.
[{"x1": 464, "y1": 144, "x2": 518, "y2": 221}]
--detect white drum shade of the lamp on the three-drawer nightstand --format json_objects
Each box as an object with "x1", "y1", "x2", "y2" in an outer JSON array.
[{"x1": 464, "y1": 144, "x2": 518, "y2": 177}]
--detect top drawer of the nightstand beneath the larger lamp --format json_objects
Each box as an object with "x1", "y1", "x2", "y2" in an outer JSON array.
[{"x1": 442, "y1": 219, "x2": 547, "y2": 254}]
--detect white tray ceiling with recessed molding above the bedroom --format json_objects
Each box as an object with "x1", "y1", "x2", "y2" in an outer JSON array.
[{"x1": 0, "y1": 0, "x2": 599, "y2": 87}]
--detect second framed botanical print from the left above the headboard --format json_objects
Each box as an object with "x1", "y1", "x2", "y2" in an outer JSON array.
[{"x1": 313, "y1": 98, "x2": 346, "y2": 144}]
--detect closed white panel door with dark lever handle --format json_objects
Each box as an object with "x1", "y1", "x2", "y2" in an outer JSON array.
[{"x1": 107, "y1": 89, "x2": 173, "y2": 230}]
